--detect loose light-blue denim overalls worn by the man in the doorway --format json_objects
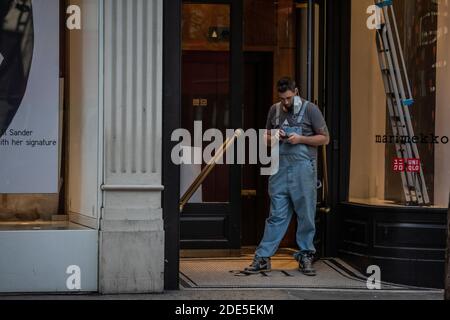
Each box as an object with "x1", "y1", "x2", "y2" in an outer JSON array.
[{"x1": 255, "y1": 97, "x2": 317, "y2": 258}]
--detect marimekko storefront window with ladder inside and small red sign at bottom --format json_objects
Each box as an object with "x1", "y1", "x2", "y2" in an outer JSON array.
[{"x1": 349, "y1": 0, "x2": 450, "y2": 207}]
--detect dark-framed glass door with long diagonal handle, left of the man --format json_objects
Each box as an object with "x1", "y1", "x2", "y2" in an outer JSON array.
[{"x1": 180, "y1": 1, "x2": 242, "y2": 249}]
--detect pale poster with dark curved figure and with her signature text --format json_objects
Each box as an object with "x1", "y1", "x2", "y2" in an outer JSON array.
[{"x1": 0, "y1": 0, "x2": 59, "y2": 193}]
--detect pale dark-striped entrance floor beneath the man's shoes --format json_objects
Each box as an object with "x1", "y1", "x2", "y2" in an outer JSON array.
[{"x1": 180, "y1": 255, "x2": 433, "y2": 291}]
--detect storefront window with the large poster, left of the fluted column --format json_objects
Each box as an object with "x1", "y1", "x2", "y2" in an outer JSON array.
[{"x1": 0, "y1": 0, "x2": 99, "y2": 224}]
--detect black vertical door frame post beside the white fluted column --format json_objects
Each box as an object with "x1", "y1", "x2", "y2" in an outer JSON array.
[{"x1": 161, "y1": 0, "x2": 181, "y2": 290}]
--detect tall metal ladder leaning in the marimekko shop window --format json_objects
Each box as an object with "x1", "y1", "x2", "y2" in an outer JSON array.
[{"x1": 375, "y1": 0, "x2": 430, "y2": 206}]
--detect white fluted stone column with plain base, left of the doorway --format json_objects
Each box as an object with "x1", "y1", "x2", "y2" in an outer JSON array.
[{"x1": 99, "y1": 0, "x2": 164, "y2": 294}]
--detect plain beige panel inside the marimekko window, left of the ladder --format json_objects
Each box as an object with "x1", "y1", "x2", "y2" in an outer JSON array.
[{"x1": 350, "y1": 0, "x2": 386, "y2": 201}]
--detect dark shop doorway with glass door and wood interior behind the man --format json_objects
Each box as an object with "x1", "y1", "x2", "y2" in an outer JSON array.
[{"x1": 180, "y1": 1, "x2": 324, "y2": 255}]
